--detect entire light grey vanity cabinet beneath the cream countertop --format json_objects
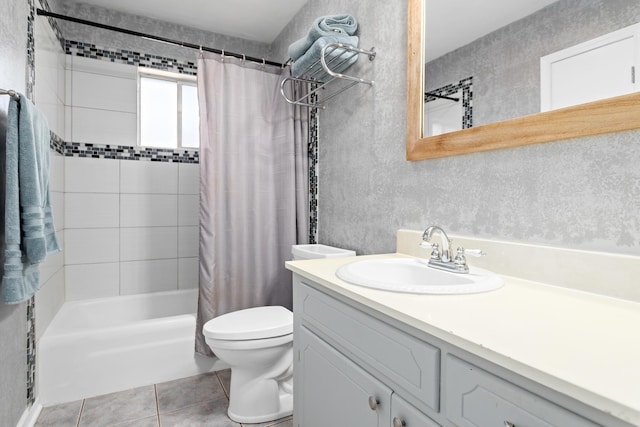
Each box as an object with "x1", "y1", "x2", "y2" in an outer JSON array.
[{"x1": 293, "y1": 273, "x2": 623, "y2": 427}]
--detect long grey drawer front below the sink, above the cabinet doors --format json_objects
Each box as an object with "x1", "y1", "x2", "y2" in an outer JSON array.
[{"x1": 294, "y1": 285, "x2": 440, "y2": 411}]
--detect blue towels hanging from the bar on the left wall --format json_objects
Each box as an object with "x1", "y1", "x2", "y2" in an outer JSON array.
[{"x1": 2, "y1": 94, "x2": 60, "y2": 304}]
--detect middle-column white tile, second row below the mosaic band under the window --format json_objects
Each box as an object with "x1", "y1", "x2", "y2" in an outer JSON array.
[{"x1": 120, "y1": 194, "x2": 178, "y2": 227}]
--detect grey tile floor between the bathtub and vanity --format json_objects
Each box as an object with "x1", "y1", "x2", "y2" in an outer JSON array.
[{"x1": 35, "y1": 370, "x2": 293, "y2": 427}]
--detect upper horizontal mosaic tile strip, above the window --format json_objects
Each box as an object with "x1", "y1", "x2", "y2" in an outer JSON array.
[{"x1": 64, "y1": 40, "x2": 198, "y2": 76}]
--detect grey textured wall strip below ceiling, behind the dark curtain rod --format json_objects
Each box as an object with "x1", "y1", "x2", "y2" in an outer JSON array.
[{"x1": 50, "y1": 0, "x2": 270, "y2": 62}]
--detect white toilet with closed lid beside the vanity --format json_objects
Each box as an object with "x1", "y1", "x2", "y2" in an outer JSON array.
[{"x1": 202, "y1": 244, "x2": 355, "y2": 424}]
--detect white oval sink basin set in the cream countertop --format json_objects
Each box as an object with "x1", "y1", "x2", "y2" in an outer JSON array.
[{"x1": 336, "y1": 258, "x2": 504, "y2": 294}]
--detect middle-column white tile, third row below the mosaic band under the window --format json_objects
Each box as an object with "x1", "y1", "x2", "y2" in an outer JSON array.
[{"x1": 120, "y1": 227, "x2": 178, "y2": 261}]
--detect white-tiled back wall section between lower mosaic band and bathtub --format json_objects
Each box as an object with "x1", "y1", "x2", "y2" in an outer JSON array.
[{"x1": 65, "y1": 157, "x2": 199, "y2": 301}]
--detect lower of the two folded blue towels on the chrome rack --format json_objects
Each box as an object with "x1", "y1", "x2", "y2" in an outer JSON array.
[{"x1": 291, "y1": 36, "x2": 360, "y2": 82}]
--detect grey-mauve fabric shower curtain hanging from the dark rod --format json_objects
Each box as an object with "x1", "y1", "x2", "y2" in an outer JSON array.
[{"x1": 196, "y1": 52, "x2": 309, "y2": 356}]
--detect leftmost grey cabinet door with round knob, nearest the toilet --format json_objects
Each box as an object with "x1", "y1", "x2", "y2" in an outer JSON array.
[{"x1": 294, "y1": 327, "x2": 391, "y2": 427}]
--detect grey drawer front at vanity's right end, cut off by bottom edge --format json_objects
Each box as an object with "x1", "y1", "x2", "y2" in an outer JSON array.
[{"x1": 444, "y1": 355, "x2": 597, "y2": 427}]
